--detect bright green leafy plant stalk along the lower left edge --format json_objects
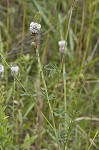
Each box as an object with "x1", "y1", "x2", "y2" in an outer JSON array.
[{"x1": 0, "y1": 86, "x2": 12, "y2": 150}]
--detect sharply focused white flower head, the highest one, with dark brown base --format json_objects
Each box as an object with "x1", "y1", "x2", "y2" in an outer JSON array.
[{"x1": 30, "y1": 22, "x2": 41, "y2": 34}]
